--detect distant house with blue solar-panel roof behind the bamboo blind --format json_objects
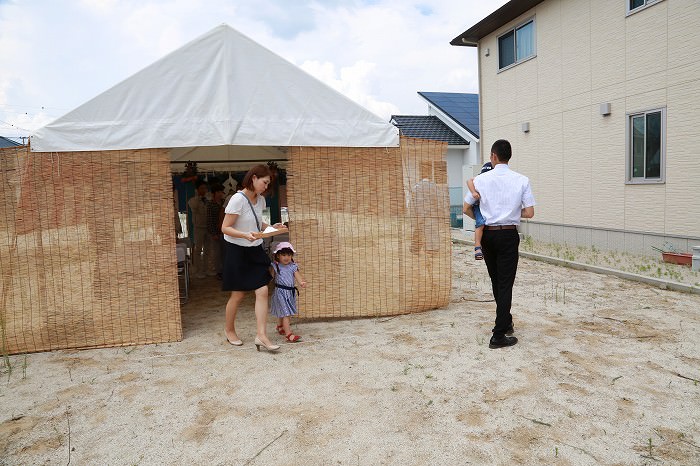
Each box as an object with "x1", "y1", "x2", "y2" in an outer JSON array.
[{"x1": 391, "y1": 92, "x2": 481, "y2": 230}]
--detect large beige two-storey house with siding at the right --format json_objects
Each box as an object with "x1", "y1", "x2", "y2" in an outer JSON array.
[{"x1": 451, "y1": 0, "x2": 700, "y2": 255}]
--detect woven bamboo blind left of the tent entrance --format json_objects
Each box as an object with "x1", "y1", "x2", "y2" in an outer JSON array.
[{"x1": 0, "y1": 146, "x2": 182, "y2": 354}]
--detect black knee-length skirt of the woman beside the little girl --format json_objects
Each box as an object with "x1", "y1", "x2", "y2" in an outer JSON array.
[{"x1": 221, "y1": 240, "x2": 272, "y2": 291}]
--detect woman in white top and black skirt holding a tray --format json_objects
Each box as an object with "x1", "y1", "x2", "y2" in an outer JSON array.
[{"x1": 221, "y1": 165, "x2": 285, "y2": 351}]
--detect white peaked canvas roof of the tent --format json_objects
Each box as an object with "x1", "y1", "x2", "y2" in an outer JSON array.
[{"x1": 31, "y1": 24, "x2": 399, "y2": 157}]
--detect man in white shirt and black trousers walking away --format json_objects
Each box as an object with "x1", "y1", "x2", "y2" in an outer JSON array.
[{"x1": 464, "y1": 139, "x2": 535, "y2": 348}]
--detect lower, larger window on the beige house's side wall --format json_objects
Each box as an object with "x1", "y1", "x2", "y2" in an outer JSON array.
[{"x1": 627, "y1": 109, "x2": 666, "y2": 183}]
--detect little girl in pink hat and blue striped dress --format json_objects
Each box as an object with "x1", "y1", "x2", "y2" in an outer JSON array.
[{"x1": 270, "y1": 241, "x2": 306, "y2": 343}]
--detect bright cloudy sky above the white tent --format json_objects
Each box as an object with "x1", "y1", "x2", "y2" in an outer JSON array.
[{"x1": 0, "y1": 0, "x2": 507, "y2": 138}]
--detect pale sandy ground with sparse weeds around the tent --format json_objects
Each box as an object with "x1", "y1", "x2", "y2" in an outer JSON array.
[{"x1": 0, "y1": 238, "x2": 700, "y2": 465}]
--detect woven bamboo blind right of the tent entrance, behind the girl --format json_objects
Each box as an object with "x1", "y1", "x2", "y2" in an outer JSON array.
[{"x1": 287, "y1": 137, "x2": 452, "y2": 318}]
